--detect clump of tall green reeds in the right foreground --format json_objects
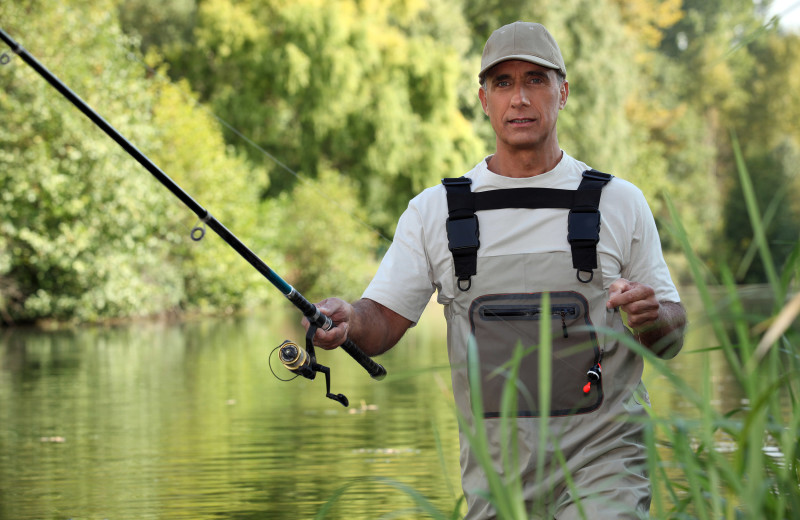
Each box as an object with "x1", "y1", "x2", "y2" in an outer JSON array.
[{"x1": 640, "y1": 132, "x2": 800, "y2": 519}]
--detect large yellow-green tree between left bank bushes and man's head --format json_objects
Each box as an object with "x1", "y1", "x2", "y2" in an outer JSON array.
[{"x1": 132, "y1": 0, "x2": 482, "y2": 234}]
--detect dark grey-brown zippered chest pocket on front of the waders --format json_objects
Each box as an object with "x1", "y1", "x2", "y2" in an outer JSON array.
[{"x1": 469, "y1": 291, "x2": 603, "y2": 417}]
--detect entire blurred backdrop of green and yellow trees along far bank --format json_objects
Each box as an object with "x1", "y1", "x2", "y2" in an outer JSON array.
[{"x1": 0, "y1": 0, "x2": 800, "y2": 324}]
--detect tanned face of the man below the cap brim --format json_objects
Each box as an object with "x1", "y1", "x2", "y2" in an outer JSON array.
[{"x1": 478, "y1": 60, "x2": 569, "y2": 152}]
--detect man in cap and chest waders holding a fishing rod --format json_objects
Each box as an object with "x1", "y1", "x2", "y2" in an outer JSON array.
[{"x1": 315, "y1": 22, "x2": 686, "y2": 520}]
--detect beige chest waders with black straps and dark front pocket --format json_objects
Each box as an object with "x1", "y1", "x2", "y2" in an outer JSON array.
[{"x1": 443, "y1": 170, "x2": 649, "y2": 520}]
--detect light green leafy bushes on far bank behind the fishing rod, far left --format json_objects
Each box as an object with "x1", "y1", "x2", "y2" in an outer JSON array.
[{"x1": 0, "y1": 0, "x2": 268, "y2": 322}]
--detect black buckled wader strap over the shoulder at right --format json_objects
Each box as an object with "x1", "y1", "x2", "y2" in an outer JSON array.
[{"x1": 567, "y1": 170, "x2": 613, "y2": 283}]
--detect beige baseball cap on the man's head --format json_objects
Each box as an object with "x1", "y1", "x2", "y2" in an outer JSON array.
[{"x1": 478, "y1": 22, "x2": 567, "y2": 83}]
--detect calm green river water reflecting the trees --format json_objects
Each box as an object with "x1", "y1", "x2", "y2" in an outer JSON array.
[{"x1": 0, "y1": 286, "x2": 792, "y2": 520}]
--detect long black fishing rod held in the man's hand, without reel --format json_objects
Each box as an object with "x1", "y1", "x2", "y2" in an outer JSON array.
[{"x1": 0, "y1": 29, "x2": 386, "y2": 386}]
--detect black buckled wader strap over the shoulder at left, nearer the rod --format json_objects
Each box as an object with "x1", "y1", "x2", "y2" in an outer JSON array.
[{"x1": 442, "y1": 177, "x2": 480, "y2": 291}]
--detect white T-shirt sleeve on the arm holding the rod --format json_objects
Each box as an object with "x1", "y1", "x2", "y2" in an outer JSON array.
[{"x1": 362, "y1": 202, "x2": 435, "y2": 323}]
